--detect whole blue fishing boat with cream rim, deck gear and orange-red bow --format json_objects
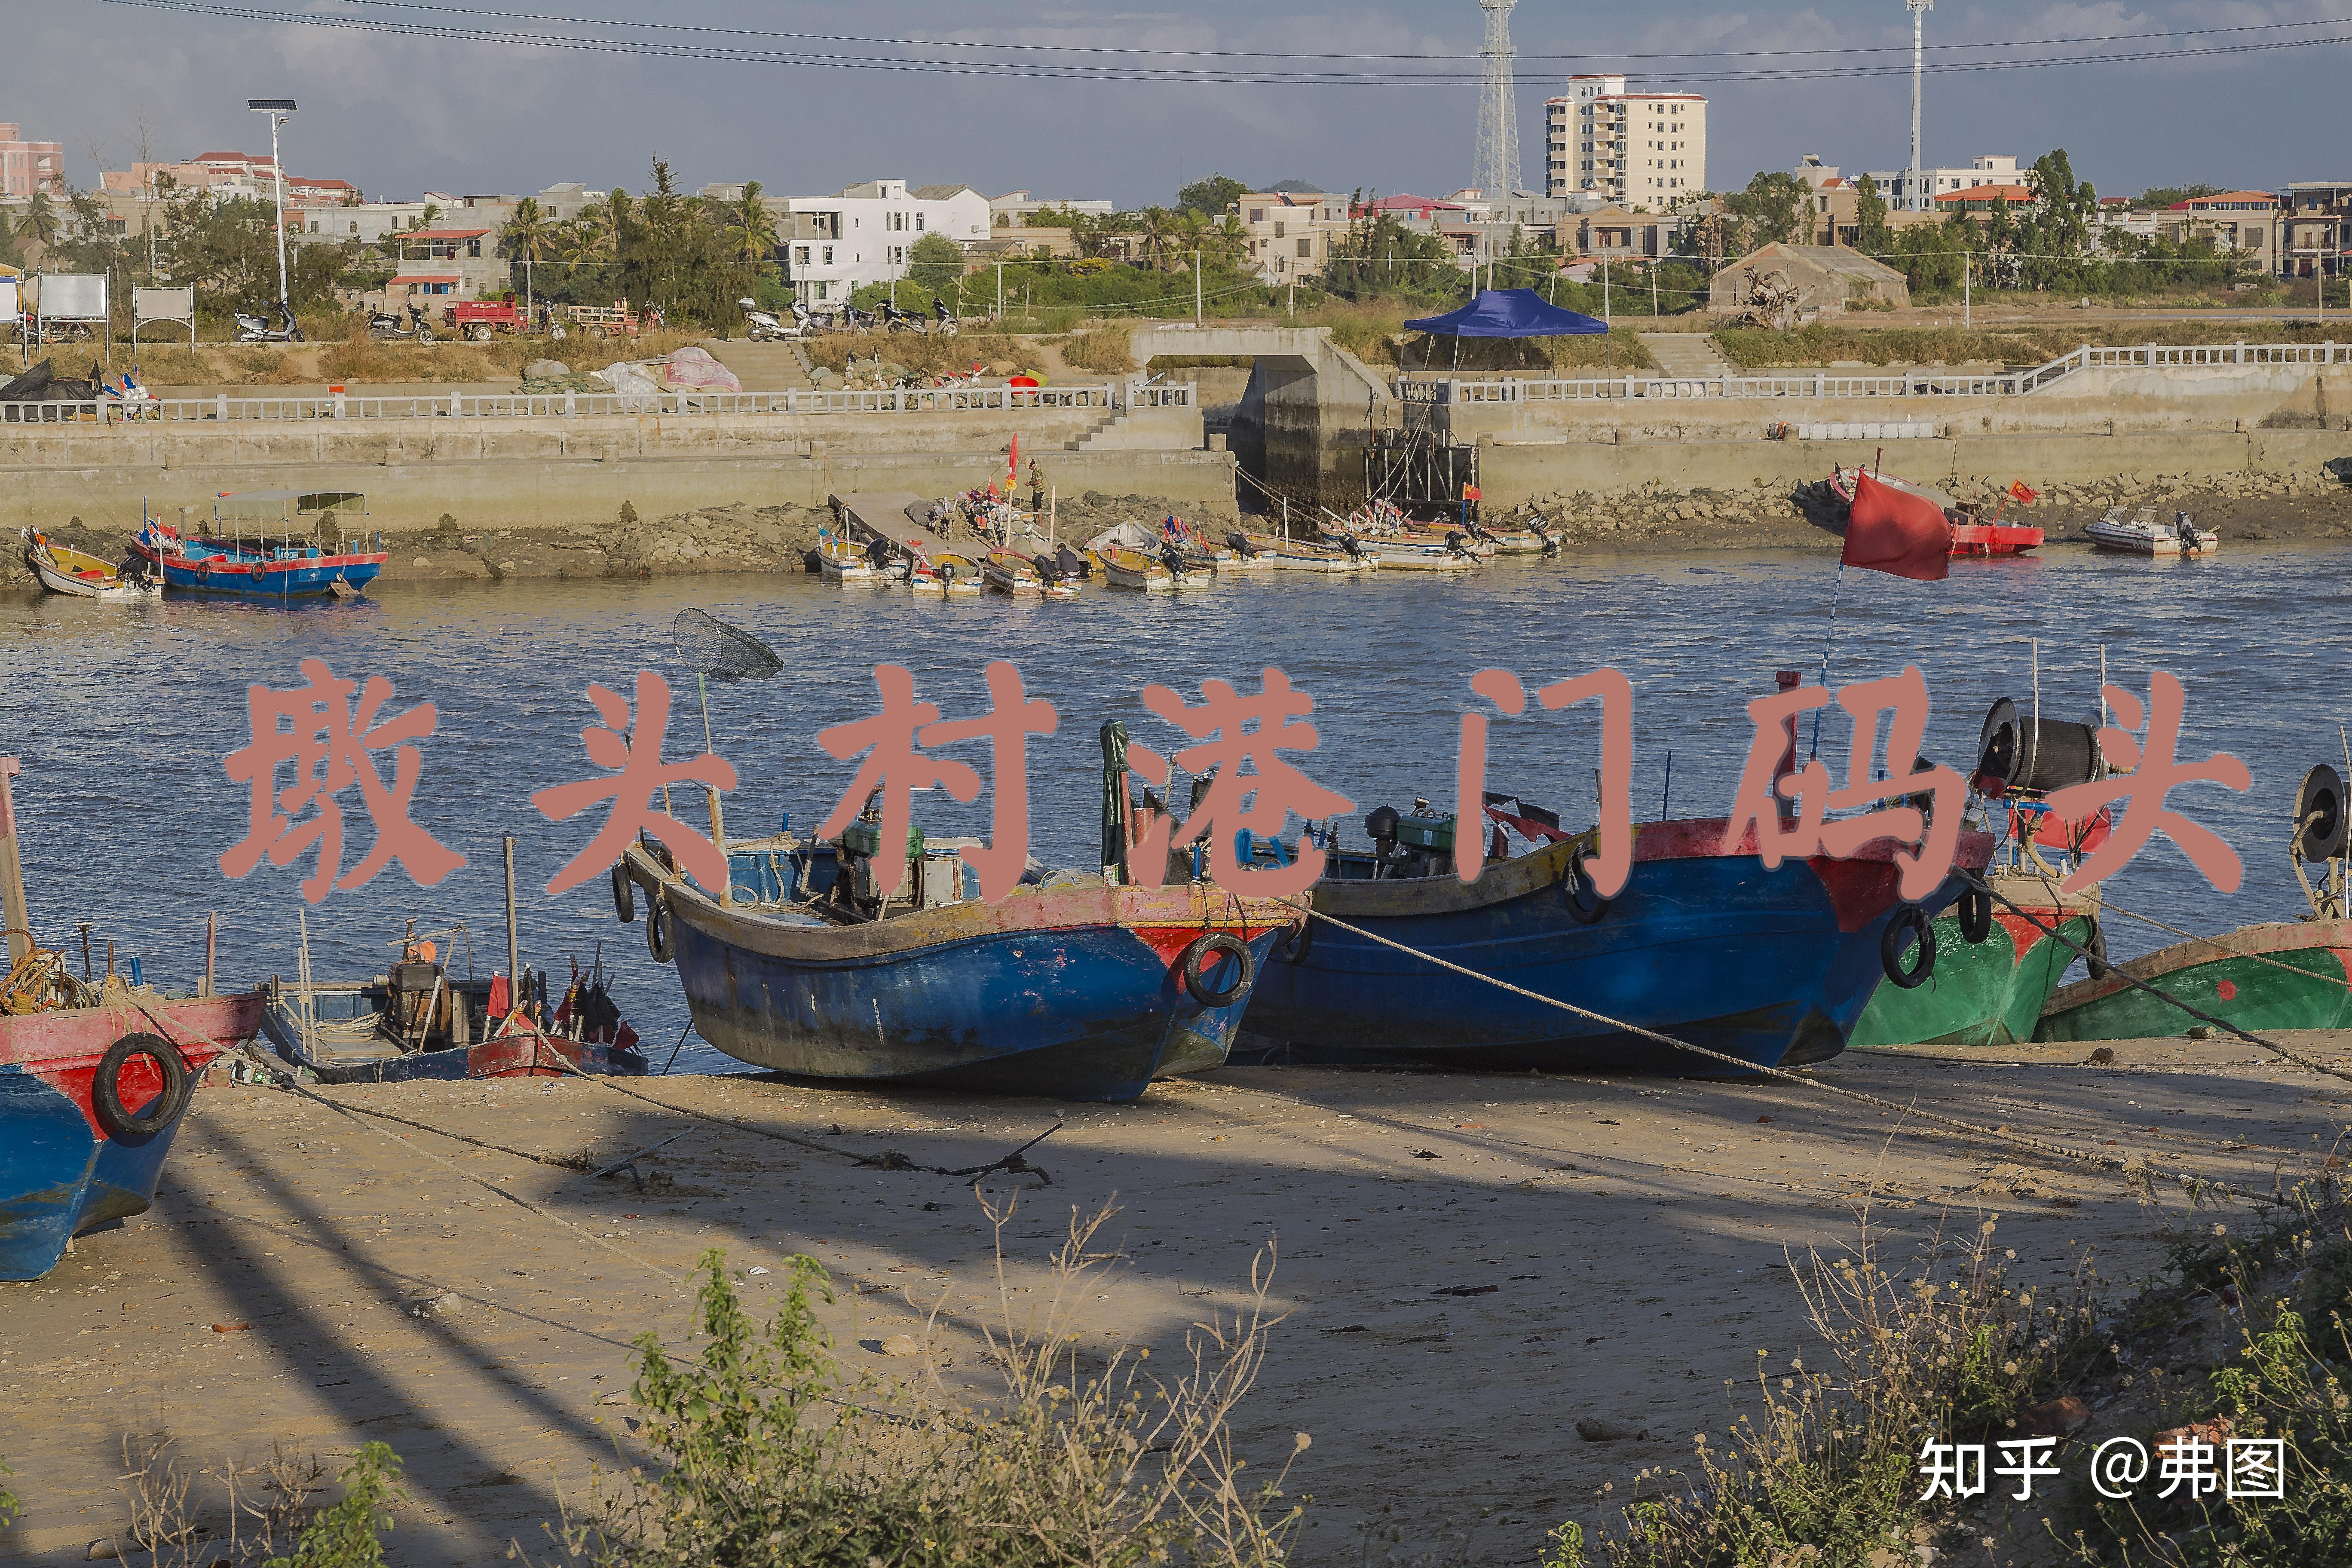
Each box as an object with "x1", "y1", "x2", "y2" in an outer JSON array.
[{"x1": 612, "y1": 743, "x2": 1301, "y2": 1100}]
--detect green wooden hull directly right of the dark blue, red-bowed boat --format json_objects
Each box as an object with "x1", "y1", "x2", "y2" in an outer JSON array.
[{"x1": 1847, "y1": 877, "x2": 2098, "y2": 1051}]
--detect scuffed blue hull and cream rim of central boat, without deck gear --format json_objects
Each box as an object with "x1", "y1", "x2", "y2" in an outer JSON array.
[{"x1": 623, "y1": 848, "x2": 1296, "y2": 1100}]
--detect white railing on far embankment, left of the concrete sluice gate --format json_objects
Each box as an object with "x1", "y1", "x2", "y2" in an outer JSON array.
[{"x1": 0, "y1": 381, "x2": 1176, "y2": 426}]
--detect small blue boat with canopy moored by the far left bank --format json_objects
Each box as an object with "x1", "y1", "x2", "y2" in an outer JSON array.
[{"x1": 132, "y1": 489, "x2": 386, "y2": 600}]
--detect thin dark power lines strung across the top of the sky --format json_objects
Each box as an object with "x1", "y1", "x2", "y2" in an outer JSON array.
[{"x1": 83, "y1": 0, "x2": 2352, "y2": 87}]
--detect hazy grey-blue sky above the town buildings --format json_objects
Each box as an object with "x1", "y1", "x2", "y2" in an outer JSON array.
[{"x1": 18, "y1": 0, "x2": 2352, "y2": 207}]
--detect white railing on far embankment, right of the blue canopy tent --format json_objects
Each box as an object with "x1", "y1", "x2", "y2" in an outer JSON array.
[{"x1": 1397, "y1": 341, "x2": 2352, "y2": 407}]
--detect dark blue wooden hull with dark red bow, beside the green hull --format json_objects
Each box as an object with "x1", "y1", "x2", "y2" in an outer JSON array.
[{"x1": 1249, "y1": 821, "x2": 1992, "y2": 1077}]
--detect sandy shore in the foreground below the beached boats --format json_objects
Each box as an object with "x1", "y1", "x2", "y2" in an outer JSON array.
[{"x1": 0, "y1": 1032, "x2": 2352, "y2": 1566}]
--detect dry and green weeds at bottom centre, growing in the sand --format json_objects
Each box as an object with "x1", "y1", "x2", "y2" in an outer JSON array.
[{"x1": 534, "y1": 1204, "x2": 1308, "y2": 1568}]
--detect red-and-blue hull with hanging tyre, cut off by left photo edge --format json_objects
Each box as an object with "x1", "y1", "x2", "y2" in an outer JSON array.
[{"x1": 0, "y1": 990, "x2": 263, "y2": 1279}]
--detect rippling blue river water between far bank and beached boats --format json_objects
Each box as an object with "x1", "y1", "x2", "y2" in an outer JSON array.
[{"x1": 0, "y1": 545, "x2": 2352, "y2": 1072}]
